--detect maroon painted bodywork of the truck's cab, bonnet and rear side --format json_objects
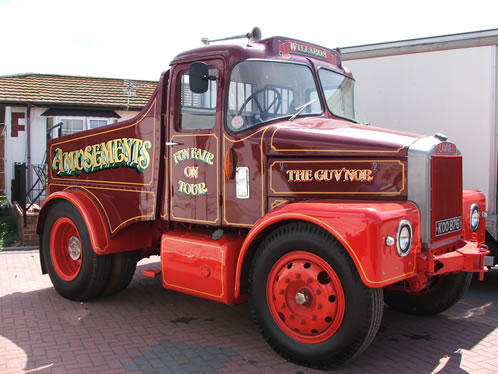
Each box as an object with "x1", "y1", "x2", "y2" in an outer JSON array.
[{"x1": 45, "y1": 37, "x2": 428, "y2": 236}]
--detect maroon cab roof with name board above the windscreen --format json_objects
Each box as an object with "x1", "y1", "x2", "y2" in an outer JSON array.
[{"x1": 171, "y1": 36, "x2": 351, "y2": 75}]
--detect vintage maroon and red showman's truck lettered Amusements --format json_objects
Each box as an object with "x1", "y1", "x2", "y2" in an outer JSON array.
[{"x1": 37, "y1": 30, "x2": 488, "y2": 367}]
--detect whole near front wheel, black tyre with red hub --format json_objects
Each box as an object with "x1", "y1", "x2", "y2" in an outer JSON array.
[{"x1": 249, "y1": 223, "x2": 383, "y2": 369}]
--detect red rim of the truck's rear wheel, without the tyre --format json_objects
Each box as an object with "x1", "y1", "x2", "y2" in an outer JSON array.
[{"x1": 50, "y1": 217, "x2": 81, "y2": 282}]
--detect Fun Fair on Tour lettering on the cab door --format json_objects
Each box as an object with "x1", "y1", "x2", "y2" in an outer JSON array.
[{"x1": 173, "y1": 148, "x2": 214, "y2": 197}]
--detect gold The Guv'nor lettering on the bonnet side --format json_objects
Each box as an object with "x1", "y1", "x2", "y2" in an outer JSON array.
[{"x1": 286, "y1": 168, "x2": 374, "y2": 182}]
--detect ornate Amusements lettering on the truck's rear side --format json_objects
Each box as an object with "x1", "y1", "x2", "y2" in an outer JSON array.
[{"x1": 52, "y1": 138, "x2": 152, "y2": 176}]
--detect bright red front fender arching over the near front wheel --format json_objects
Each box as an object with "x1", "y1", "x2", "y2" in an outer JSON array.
[{"x1": 235, "y1": 200, "x2": 421, "y2": 297}]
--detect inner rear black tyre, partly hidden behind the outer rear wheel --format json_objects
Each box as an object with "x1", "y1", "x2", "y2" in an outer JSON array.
[{"x1": 102, "y1": 252, "x2": 138, "y2": 296}]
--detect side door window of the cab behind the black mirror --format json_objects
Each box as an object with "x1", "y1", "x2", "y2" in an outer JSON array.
[{"x1": 180, "y1": 70, "x2": 217, "y2": 130}]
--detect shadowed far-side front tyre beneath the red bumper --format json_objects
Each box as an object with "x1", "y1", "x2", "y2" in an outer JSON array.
[{"x1": 384, "y1": 273, "x2": 472, "y2": 316}]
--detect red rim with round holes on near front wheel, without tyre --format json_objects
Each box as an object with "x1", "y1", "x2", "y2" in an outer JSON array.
[{"x1": 266, "y1": 252, "x2": 346, "y2": 344}]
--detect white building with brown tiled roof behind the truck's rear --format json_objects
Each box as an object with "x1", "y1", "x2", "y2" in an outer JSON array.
[{"x1": 0, "y1": 74, "x2": 157, "y2": 207}]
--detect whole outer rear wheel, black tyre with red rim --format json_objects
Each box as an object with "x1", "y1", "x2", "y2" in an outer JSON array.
[{"x1": 40, "y1": 201, "x2": 111, "y2": 301}]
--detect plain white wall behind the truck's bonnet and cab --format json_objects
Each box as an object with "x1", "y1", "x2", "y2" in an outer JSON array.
[{"x1": 344, "y1": 46, "x2": 496, "y2": 210}]
